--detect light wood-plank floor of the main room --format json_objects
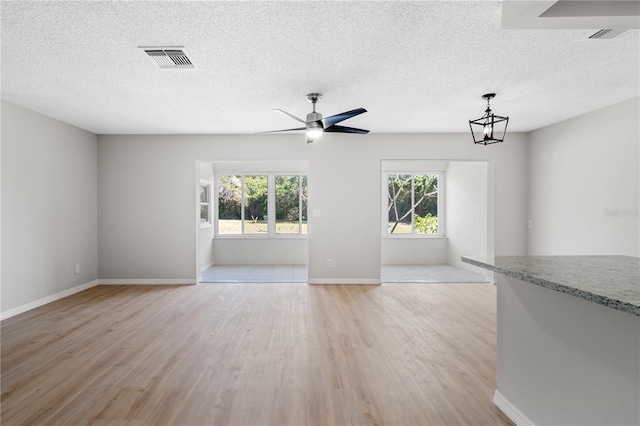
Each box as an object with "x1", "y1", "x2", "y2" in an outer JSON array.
[{"x1": 0, "y1": 283, "x2": 511, "y2": 425}]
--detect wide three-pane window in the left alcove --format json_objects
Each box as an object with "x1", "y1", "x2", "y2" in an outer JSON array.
[{"x1": 216, "y1": 173, "x2": 307, "y2": 236}]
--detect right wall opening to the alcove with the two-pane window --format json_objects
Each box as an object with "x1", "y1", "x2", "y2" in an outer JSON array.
[{"x1": 380, "y1": 160, "x2": 494, "y2": 283}]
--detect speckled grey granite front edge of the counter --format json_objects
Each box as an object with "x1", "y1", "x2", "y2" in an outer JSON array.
[{"x1": 462, "y1": 256, "x2": 640, "y2": 316}]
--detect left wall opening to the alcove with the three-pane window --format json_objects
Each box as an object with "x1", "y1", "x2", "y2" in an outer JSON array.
[{"x1": 196, "y1": 161, "x2": 308, "y2": 283}]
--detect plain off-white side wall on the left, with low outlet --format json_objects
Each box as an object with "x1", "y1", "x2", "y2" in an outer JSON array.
[{"x1": 1, "y1": 101, "x2": 98, "y2": 313}]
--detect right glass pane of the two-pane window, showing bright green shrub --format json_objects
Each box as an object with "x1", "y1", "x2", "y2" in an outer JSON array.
[{"x1": 413, "y1": 174, "x2": 438, "y2": 234}]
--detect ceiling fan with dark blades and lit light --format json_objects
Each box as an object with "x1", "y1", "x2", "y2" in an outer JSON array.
[{"x1": 260, "y1": 93, "x2": 369, "y2": 143}]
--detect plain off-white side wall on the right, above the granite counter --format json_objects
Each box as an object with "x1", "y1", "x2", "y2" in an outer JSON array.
[{"x1": 527, "y1": 98, "x2": 640, "y2": 256}]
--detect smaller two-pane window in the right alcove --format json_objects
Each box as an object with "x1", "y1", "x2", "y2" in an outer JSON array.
[{"x1": 384, "y1": 171, "x2": 444, "y2": 237}]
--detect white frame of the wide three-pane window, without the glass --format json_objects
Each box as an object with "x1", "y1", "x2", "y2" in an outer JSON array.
[{"x1": 213, "y1": 171, "x2": 309, "y2": 238}]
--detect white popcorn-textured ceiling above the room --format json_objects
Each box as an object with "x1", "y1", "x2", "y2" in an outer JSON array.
[{"x1": 1, "y1": 1, "x2": 640, "y2": 134}]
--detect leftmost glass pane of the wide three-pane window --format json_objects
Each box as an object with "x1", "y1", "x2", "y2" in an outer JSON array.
[{"x1": 218, "y1": 175, "x2": 242, "y2": 234}]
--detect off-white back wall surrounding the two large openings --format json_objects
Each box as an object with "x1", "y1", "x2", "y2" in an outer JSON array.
[{"x1": 98, "y1": 133, "x2": 526, "y2": 282}]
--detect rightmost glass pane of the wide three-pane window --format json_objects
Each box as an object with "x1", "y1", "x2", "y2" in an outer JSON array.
[{"x1": 276, "y1": 176, "x2": 300, "y2": 234}]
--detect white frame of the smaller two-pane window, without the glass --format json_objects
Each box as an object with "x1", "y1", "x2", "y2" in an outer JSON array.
[{"x1": 380, "y1": 169, "x2": 447, "y2": 238}]
